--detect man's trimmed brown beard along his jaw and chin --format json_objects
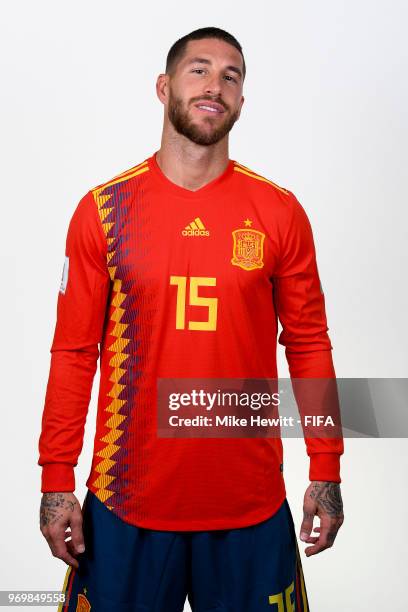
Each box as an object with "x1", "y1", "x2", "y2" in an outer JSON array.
[{"x1": 168, "y1": 89, "x2": 238, "y2": 146}]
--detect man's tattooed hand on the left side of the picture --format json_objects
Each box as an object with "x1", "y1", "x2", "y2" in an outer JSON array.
[{"x1": 40, "y1": 492, "x2": 85, "y2": 569}]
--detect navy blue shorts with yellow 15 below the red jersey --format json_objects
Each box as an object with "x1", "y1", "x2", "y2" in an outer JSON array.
[{"x1": 58, "y1": 489, "x2": 309, "y2": 612}]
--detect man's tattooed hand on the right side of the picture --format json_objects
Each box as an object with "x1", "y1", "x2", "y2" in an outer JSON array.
[{"x1": 300, "y1": 480, "x2": 344, "y2": 557}]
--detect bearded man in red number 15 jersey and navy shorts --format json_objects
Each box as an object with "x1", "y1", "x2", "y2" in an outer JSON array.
[{"x1": 38, "y1": 27, "x2": 343, "y2": 612}]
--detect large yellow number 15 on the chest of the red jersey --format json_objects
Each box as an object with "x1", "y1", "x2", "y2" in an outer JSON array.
[{"x1": 170, "y1": 276, "x2": 218, "y2": 331}]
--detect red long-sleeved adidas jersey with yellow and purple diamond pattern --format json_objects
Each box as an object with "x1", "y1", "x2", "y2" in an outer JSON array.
[{"x1": 38, "y1": 153, "x2": 344, "y2": 530}]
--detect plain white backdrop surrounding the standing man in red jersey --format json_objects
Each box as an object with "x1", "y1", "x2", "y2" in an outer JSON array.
[{"x1": 0, "y1": 0, "x2": 408, "y2": 612}]
